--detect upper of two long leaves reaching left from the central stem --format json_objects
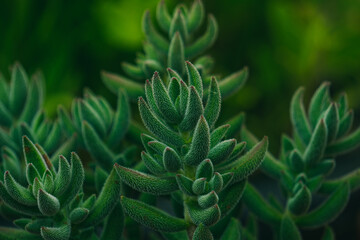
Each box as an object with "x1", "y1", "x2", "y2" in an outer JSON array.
[{"x1": 115, "y1": 164, "x2": 178, "y2": 195}]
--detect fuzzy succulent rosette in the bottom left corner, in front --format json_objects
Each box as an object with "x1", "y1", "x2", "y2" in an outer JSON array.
[{"x1": 0, "y1": 136, "x2": 123, "y2": 240}]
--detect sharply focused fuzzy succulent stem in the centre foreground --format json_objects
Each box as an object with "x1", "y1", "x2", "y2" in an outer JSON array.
[{"x1": 115, "y1": 62, "x2": 267, "y2": 239}]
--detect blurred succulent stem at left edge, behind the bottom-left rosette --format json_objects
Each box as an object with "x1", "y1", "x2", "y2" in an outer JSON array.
[{"x1": 0, "y1": 63, "x2": 75, "y2": 183}]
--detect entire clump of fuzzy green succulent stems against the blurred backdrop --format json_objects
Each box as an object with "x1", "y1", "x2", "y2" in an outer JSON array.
[{"x1": 0, "y1": 0, "x2": 360, "y2": 240}]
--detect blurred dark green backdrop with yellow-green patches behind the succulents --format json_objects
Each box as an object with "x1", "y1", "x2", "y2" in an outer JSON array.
[{"x1": 0, "y1": 0, "x2": 360, "y2": 239}]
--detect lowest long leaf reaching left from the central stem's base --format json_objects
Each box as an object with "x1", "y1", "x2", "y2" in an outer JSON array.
[{"x1": 121, "y1": 196, "x2": 188, "y2": 232}]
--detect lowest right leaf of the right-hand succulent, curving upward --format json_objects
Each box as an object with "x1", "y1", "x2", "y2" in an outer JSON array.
[{"x1": 295, "y1": 183, "x2": 350, "y2": 228}]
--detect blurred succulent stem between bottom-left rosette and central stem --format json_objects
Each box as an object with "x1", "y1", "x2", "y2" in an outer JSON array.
[{"x1": 58, "y1": 90, "x2": 132, "y2": 171}]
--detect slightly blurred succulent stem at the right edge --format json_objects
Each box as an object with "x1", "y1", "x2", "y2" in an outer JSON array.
[{"x1": 242, "y1": 82, "x2": 360, "y2": 239}]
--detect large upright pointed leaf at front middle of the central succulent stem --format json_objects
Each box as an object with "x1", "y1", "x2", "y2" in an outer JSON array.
[{"x1": 184, "y1": 116, "x2": 210, "y2": 166}]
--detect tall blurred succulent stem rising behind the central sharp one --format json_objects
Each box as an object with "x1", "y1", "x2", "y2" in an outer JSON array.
[{"x1": 102, "y1": 0, "x2": 248, "y2": 100}]
